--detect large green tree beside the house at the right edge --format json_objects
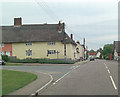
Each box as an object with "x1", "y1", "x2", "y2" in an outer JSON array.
[{"x1": 102, "y1": 44, "x2": 113, "y2": 59}]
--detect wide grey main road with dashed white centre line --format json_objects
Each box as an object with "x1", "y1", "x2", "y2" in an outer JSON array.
[{"x1": 39, "y1": 60, "x2": 118, "y2": 95}]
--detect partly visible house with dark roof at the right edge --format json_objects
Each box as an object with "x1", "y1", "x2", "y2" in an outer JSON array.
[{"x1": 113, "y1": 41, "x2": 120, "y2": 60}]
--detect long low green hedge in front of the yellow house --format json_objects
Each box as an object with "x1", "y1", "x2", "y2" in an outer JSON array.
[{"x1": 9, "y1": 59, "x2": 75, "y2": 64}]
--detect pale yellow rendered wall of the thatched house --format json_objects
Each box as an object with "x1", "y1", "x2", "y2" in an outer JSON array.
[{"x1": 12, "y1": 42, "x2": 74, "y2": 59}]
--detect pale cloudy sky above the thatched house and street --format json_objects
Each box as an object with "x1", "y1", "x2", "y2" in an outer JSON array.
[{"x1": 0, "y1": 0, "x2": 119, "y2": 50}]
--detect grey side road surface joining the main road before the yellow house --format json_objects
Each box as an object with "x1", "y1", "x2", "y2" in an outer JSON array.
[{"x1": 2, "y1": 64, "x2": 74, "y2": 81}]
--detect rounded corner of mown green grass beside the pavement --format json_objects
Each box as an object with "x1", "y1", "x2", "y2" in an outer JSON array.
[{"x1": 2, "y1": 70, "x2": 37, "y2": 95}]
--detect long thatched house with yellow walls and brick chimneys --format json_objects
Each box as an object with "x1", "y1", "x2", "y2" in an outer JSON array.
[{"x1": 1, "y1": 18, "x2": 77, "y2": 60}]
